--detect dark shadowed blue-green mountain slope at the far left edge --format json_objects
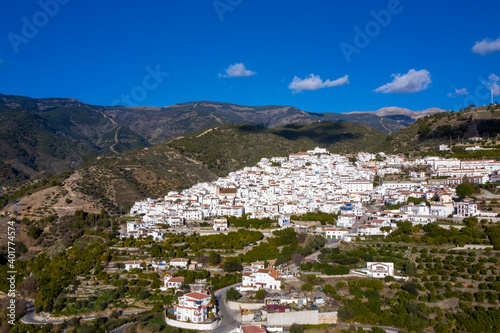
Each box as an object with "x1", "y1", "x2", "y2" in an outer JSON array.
[{"x1": 0, "y1": 95, "x2": 149, "y2": 183}]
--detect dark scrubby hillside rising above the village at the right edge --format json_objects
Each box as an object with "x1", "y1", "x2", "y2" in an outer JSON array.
[{"x1": 389, "y1": 104, "x2": 500, "y2": 152}]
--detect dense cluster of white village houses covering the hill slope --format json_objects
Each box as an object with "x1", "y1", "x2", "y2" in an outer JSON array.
[{"x1": 127, "y1": 148, "x2": 500, "y2": 239}]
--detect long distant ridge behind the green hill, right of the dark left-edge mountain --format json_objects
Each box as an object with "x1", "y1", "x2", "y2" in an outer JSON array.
[{"x1": 104, "y1": 101, "x2": 405, "y2": 144}]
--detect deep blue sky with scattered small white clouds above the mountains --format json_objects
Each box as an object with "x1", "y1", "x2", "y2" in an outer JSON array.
[{"x1": 0, "y1": 0, "x2": 500, "y2": 112}]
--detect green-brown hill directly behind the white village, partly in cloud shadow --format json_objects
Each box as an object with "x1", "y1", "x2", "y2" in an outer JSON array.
[{"x1": 69, "y1": 122, "x2": 386, "y2": 211}]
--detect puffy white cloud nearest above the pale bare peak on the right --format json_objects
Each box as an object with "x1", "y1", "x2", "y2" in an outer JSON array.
[{"x1": 374, "y1": 69, "x2": 432, "y2": 94}]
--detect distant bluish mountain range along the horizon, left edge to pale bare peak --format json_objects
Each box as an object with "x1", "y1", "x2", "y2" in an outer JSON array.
[{"x1": 0, "y1": 94, "x2": 443, "y2": 184}]
